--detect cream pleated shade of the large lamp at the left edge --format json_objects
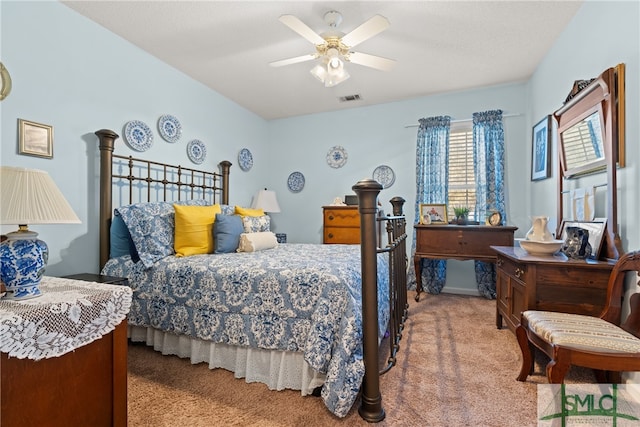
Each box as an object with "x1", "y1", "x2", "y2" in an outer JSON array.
[{"x1": 0, "y1": 166, "x2": 80, "y2": 225}]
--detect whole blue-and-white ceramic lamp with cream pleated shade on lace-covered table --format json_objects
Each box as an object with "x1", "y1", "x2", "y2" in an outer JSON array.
[{"x1": 0, "y1": 166, "x2": 80, "y2": 300}]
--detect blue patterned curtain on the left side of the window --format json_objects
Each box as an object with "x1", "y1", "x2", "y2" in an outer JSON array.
[{"x1": 408, "y1": 116, "x2": 451, "y2": 294}]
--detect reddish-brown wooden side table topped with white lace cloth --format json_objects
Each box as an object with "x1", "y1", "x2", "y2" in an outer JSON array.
[{"x1": 0, "y1": 276, "x2": 131, "y2": 427}]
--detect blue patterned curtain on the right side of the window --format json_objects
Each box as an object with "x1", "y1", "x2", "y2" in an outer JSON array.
[{"x1": 473, "y1": 110, "x2": 507, "y2": 299}]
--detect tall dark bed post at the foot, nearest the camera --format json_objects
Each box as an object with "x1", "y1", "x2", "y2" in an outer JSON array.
[{"x1": 351, "y1": 178, "x2": 385, "y2": 423}]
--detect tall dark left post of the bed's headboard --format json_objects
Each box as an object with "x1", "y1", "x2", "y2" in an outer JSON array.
[{"x1": 95, "y1": 129, "x2": 120, "y2": 271}]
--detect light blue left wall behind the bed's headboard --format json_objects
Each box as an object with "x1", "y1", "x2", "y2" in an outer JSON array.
[{"x1": 0, "y1": 1, "x2": 269, "y2": 275}]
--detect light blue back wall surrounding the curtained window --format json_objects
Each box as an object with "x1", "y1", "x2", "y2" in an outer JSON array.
[{"x1": 269, "y1": 84, "x2": 529, "y2": 294}]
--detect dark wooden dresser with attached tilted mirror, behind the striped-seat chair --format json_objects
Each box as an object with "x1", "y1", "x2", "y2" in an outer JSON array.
[{"x1": 492, "y1": 64, "x2": 624, "y2": 331}]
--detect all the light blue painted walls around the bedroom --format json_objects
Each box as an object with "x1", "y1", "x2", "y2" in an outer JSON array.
[{"x1": 0, "y1": 1, "x2": 640, "y2": 293}]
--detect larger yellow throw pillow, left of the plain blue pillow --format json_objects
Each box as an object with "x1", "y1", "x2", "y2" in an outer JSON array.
[{"x1": 173, "y1": 205, "x2": 222, "y2": 256}]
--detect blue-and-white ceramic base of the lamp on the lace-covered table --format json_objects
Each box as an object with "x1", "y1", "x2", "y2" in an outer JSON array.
[{"x1": 0, "y1": 232, "x2": 49, "y2": 300}]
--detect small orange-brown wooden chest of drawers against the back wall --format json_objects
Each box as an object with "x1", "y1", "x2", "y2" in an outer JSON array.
[{"x1": 322, "y1": 206, "x2": 360, "y2": 244}]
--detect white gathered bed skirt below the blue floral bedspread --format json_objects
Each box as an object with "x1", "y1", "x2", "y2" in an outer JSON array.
[{"x1": 129, "y1": 326, "x2": 325, "y2": 396}]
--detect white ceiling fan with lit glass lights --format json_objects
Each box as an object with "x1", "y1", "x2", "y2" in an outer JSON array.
[{"x1": 269, "y1": 10, "x2": 395, "y2": 87}]
